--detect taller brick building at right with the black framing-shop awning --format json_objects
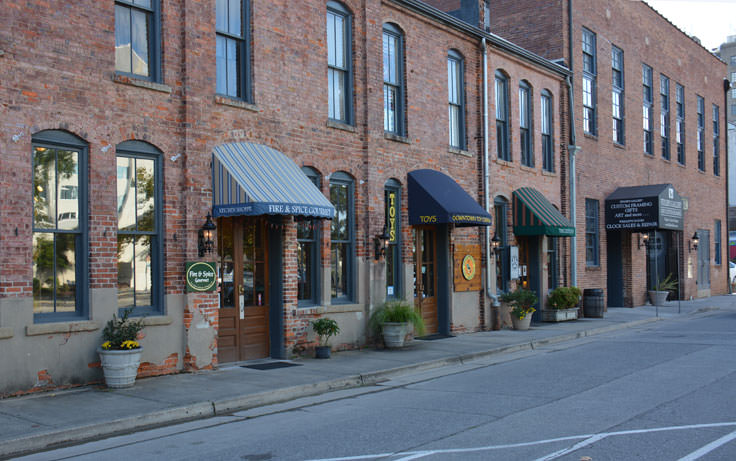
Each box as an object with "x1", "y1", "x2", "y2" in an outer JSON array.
[{"x1": 474, "y1": 0, "x2": 728, "y2": 306}]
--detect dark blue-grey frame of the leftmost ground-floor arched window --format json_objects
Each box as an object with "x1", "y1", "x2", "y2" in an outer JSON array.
[{"x1": 31, "y1": 130, "x2": 90, "y2": 323}]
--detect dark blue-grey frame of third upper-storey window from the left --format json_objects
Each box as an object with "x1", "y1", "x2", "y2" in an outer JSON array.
[{"x1": 326, "y1": 1, "x2": 355, "y2": 125}]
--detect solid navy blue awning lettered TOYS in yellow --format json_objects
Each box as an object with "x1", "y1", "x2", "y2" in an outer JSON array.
[{"x1": 408, "y1": 170, "x2": 491, "y2": 226}]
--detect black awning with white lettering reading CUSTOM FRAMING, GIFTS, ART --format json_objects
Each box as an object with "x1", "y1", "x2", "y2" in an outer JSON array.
[{"x1": 606, "y1": 184, "x2": 684, "y2": 228}]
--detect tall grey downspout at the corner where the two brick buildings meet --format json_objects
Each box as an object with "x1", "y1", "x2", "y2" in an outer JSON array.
[{"x1": 567, "y1": 0, "x2": 580, "y2": 286}]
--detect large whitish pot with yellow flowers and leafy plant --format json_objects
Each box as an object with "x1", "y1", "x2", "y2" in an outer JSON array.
[{"x1": 97, "y1": 308, "x2": 143, "y2": 389}]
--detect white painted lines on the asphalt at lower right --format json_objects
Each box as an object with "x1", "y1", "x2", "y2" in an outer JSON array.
[{"x1": 308, "y1": 422, "x2": 736, "y2": 461}]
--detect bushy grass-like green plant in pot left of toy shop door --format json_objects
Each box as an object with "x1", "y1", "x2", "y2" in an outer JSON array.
[{"x1": 370, "y1": 301, "x2": 424, "y2": 348}]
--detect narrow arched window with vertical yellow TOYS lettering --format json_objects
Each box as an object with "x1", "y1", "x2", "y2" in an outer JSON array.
[{"x1": 384, "y1": 179, "x2": 402, "y2": 299}]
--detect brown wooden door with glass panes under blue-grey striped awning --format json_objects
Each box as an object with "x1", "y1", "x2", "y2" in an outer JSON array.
[{"x1": 217, "y1": 217, "x2": 269, "y2": 363}]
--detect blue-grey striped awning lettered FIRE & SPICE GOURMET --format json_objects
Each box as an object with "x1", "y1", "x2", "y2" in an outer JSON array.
[{"x1": 212, "y1": 142, "x2": 335, "y2": 219}]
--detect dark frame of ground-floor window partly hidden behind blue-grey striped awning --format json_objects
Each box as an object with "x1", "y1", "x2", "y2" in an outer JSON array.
[{"x1": 296, "y1": 166, "x2": 322, "y2": 307}]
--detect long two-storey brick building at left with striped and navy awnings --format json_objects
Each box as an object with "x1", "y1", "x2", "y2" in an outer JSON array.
[{"x1": 0, "y1": 0, "x2": 574, "y2": 395}]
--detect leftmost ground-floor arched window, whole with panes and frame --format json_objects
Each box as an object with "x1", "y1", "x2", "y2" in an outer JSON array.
[{"x1": 32, "y1": 130, "x2": 89, "y2": 322}]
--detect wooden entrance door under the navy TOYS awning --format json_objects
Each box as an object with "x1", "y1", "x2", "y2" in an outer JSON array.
[{"x1": 414, "y1": 227, "x2": 439, "y2": 334}]
